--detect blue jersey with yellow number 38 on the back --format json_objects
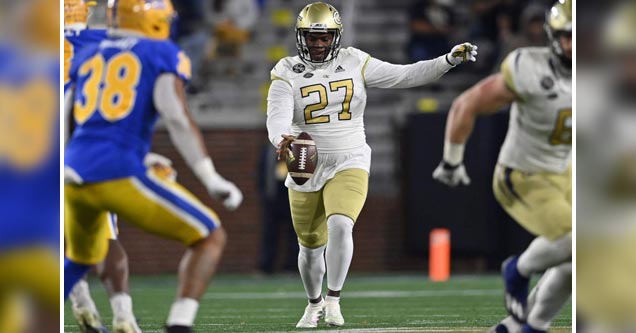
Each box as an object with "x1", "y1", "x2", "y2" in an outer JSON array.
[{"x1": 65, "y1": 37, "x2": 191, "y2": 182}]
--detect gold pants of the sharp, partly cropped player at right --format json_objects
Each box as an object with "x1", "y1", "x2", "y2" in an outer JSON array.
[{"x1": 493, "y1": 165, "x2": 572, "y2": 240}]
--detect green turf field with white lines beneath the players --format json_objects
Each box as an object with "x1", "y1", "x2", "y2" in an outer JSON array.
[{"x1": 64, "y1": 274, "x2": 572, "y2": 333}]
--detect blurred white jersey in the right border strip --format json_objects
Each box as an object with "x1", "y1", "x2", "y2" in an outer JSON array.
[{"x1": 576, "y1": 69, "x2": 636, "y2": 234}]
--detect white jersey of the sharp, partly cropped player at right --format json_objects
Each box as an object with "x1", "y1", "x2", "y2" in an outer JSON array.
[{"x1": 499, "y1": 48, "x2": 572, "y2": 173}]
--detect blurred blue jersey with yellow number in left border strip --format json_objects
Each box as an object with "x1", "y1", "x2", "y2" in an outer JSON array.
[{"x1": 0, "y1": 44, "x2": 60, "y2": 250}]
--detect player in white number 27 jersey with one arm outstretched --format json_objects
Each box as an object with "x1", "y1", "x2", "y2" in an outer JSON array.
[{"x1": 267, "y1": 2, "x2": 477, "y2": 328}]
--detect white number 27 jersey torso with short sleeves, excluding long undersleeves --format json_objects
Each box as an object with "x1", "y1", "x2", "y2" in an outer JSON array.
[{"x1": 271, "y1": 48, "x2": 369, "y2": 153}]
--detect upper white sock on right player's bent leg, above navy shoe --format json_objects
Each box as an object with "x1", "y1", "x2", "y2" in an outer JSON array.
[{"x1": 517, "y1": 233, "x2": 572, "y2": 277}]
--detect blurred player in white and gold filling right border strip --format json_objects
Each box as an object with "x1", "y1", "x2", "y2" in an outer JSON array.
[{"x1": 576, "y1": 1, "x2": 636, "y2": 333}]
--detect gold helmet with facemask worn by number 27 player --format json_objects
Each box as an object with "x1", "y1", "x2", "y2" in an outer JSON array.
[{"x1": 296, "y1": 2, "x2": 343, "y2": 64}]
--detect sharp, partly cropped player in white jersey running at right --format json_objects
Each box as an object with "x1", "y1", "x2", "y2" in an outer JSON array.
[{"x1": 433, "y1": 0, "x2": 572, "y2": 333}]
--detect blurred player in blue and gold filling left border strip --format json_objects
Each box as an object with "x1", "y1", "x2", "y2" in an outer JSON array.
[{"x1": 0, "y1": 0, "x2": 60, "y2": 333}]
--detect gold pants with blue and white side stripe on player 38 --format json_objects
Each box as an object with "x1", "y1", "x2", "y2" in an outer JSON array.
[{"x1": 64, "y1": 172, "x2": 220, "y2": 265}]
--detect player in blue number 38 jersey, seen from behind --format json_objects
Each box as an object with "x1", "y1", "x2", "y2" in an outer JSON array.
[{"x1": 64, "y1": 0, "x2": 243, "y2": 333}]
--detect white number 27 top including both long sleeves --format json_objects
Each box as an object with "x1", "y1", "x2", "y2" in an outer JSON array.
[{"x1": 267, "y1": 47, "x2": 453, "y2": 192}]
